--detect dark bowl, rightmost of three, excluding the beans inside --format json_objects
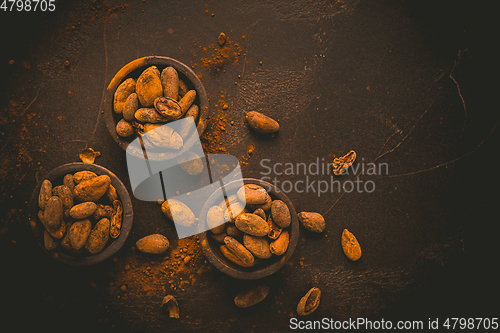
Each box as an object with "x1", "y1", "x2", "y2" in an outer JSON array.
[{"x1": 199, "y1": 178, "x2": 299, "y2": 280}]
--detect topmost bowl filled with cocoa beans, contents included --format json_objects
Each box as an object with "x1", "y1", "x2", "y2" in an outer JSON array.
[{"x1": 102, "y1": 56, "x2": 208, "y2": 160}]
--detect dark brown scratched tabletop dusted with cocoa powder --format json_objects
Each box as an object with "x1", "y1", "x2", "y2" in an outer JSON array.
[{"x1": 0, "y1": 0, "x2": 499, "y2": 332}]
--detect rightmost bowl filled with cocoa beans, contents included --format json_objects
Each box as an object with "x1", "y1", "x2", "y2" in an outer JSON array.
[{"x1": 199, "y1": 178, "x2": 299, "y2": 280}]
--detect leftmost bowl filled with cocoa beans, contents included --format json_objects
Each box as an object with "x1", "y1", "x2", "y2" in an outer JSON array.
[{"x1": 29, "y1": 163, "x2": 133, "y2": 266}]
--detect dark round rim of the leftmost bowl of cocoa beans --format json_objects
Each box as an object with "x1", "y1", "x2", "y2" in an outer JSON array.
[{"x1": 28, "y1": 162, "x2": 133, "y2": 266}]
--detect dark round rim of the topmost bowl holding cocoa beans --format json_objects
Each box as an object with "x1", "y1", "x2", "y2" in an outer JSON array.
[{"x1": 102, "y1": 56, "x2": 209, "y2": 161}]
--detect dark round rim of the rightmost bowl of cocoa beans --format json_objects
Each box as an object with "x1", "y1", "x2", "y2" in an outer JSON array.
[{"x1": 198, "y1": 178, "x2": 299, "y2": 280}]
